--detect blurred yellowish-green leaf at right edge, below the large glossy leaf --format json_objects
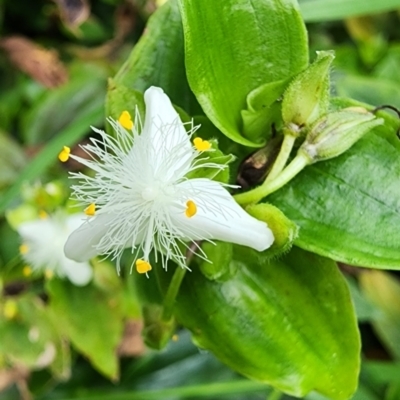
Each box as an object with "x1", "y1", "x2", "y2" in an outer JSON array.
[{"x1": 360, "y1": 271, "x2": 400, "y2": 360}]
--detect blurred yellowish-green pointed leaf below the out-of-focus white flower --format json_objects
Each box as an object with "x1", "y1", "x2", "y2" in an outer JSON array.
[{"x1": 47, "y1": 279, "x2": 123, "y2": 379}]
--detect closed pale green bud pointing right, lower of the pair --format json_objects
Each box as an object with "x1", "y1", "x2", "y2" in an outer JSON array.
[{"x1": 299, "y1": 107, "x2": 383, "y2": 162}]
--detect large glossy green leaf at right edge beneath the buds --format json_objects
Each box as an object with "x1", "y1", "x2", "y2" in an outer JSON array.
[{"x1": 268, "y1": 100, "x2": 400, "y2": 269}]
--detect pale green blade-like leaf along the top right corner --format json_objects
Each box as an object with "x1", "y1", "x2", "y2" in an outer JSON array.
[{"x1": 299, "y1": 0, "x2": 399, "y2": 22}]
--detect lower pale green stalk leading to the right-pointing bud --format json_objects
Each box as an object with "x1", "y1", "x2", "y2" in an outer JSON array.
[{"x1": 234, "y1": 153, "x2": 311, "y2": 205}]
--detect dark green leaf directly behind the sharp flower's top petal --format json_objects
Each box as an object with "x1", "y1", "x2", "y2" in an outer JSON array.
[{"x1": 114, "y1": 0, "x2": 201, "y2": 115}]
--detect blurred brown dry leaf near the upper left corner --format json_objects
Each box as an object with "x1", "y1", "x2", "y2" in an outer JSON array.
[{"x1": 0, "y1": 36, "x2": 68, "y2": 88}]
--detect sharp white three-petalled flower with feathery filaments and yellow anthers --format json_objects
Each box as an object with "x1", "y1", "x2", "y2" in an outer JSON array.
[{"x1": 60, "y1": 87, "x2": 274, "y2": 273}]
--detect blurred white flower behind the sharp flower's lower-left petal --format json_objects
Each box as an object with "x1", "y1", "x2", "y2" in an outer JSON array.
[{"x1": 17, "y1": 212, "x2": 93, "y2": 286}]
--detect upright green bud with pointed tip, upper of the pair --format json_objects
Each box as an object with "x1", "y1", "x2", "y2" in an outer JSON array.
[{"x1": 282, "y1": 51, "x2": 335, "y2": 127}]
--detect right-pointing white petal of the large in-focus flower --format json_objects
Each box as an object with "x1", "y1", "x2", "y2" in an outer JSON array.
[{"x1": 171, "y1": 179, "x2": 274, "y2": 251}]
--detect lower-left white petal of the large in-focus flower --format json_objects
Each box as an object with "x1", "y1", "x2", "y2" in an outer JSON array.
[{"x1": 64, "y1": 214, "x2": 114, "y2": 262}]
